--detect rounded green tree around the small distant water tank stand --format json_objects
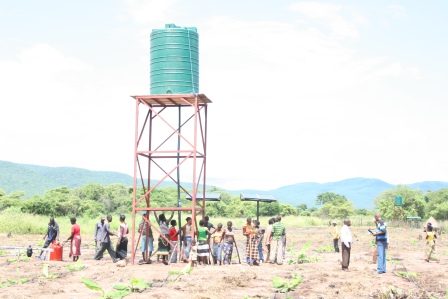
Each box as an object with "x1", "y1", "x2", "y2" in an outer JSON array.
[{"x1": 375, "y1": 185, "x2": 426, "y2": 219}]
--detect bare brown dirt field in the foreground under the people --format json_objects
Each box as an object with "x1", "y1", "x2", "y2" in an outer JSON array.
[{"x1": 0, "y1": 227, "x2": 448, "y2": 299}]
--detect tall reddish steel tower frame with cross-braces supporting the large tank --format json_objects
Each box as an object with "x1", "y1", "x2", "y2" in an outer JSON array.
[{"x1": 131, "y1": 94, "x2": 211, "y2": 264}]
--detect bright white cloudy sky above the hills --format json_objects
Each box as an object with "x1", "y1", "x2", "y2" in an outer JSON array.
[{"x1": 0, "y1": 0, "x2": 448, "y2": 190}]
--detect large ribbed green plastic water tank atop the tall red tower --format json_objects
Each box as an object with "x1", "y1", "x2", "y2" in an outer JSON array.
[{"x1": 149, "y1": 24, "x2": 199, "y2": 95}]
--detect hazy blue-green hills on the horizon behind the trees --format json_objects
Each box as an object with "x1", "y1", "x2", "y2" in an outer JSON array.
[{"x1": 0, "y1": 161, "x2": 448, "y2": 209}]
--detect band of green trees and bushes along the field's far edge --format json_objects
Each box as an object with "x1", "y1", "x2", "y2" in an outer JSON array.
[{"x1": 0, "y1": 183, "x2": 448, "y2": 219}]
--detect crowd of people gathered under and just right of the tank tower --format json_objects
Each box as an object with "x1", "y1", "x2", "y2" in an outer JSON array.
[{"x1": 138, "y1": 212, "x2": 286, "y2": 265}]
